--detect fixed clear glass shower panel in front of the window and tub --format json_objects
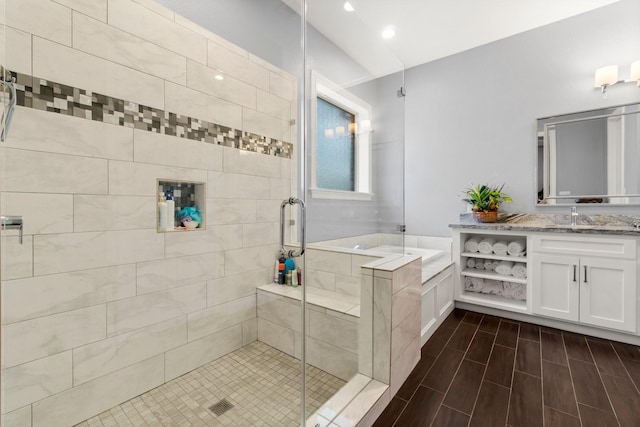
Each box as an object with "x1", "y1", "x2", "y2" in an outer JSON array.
[{"x1": 302, "y1": 0, "x2": 404, "y2": 425}]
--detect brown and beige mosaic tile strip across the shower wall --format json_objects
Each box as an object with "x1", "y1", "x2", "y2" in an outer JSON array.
[{"x1": 11, "y1": 72, "x2": 293, "y2": 159}]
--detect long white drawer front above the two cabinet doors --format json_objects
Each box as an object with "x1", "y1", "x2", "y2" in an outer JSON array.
[{"x1": 531, "y1": 234, "x2": 637, "y2": 259}]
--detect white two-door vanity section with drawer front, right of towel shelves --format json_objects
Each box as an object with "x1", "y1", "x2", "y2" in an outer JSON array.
[{"x1": 531, "y1": 233, "x2": 638, "y2": 333}]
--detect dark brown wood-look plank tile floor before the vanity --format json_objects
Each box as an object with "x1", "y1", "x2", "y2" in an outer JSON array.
[{"x1": 374, "y1": 309, "x2": 640, "y2": 427}]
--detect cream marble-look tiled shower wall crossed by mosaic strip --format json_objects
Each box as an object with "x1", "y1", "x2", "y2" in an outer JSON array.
[{"x1": 0, "y1": 0, "x2": 296, "y2": 427}]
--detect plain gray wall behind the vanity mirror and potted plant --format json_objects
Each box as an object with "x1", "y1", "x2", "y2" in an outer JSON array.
[{"x1": 405, "y1": 0, "x2": 640, "y2": 236}]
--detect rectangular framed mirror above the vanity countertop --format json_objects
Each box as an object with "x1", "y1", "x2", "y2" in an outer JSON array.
[{"x1": 536, "y1": 104, "x2": 640, "y2": 206}]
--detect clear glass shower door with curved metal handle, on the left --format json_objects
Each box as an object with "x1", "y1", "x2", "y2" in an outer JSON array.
[{"x1": 0, "y1": 0, "x2": 312, "y2": 427}]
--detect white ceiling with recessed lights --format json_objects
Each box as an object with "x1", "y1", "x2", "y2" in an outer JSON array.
[{"x1": 282, "y1": 0, "x2": 619, "y2": 76}]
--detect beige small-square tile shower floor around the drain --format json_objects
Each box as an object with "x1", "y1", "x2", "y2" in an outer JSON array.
[{"x1": 77, "y1": 341, "x2": 345, "y2": 427}]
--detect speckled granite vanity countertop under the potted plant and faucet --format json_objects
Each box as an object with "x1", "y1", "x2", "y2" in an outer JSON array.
[{"x1": 449, "y1": 213, "x2": 640, "y2": 236}]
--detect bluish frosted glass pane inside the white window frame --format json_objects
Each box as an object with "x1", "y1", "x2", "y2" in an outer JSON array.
[{"x1": 316, "y1": 98, "x2": 355, "y2": 191}]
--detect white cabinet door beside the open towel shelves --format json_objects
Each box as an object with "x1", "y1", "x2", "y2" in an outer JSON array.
[{"x1": 532, "y1": 254, "x2": 580, "y2": 321}]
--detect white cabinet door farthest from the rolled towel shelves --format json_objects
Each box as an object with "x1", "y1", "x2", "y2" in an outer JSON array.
[{"x1": 580, "y1": 257, "x2": 637, "y2": 332}]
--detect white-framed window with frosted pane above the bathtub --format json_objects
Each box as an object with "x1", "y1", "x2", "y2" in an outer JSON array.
[{"x1": 311, "y1": 72, "x2": 373, "y2": 200}]
